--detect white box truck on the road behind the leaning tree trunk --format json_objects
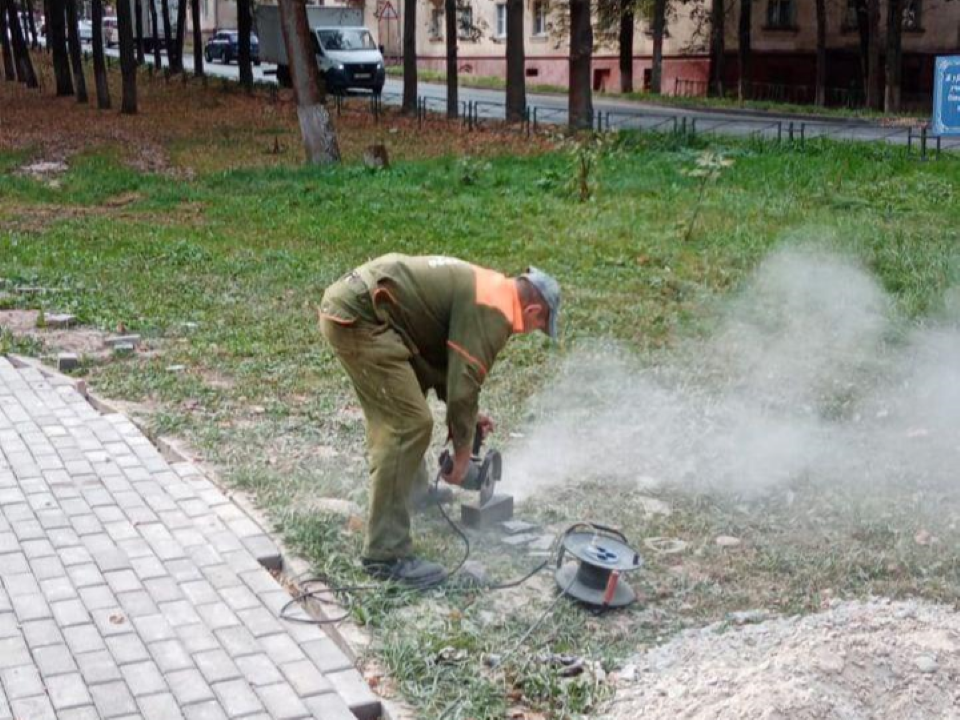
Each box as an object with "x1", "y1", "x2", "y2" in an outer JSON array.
[{"x1": 257, "y1": 5, "x2": 386, "y2": 94}]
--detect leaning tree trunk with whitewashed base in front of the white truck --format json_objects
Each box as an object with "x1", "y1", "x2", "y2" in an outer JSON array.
[{"x1": 279, "y1": 0, "x2": 340, "y2": 165}]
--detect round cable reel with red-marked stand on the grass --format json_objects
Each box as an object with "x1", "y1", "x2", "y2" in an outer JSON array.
[{"x1": 554, "y1": 523, "x2": 643, "y2": 608}]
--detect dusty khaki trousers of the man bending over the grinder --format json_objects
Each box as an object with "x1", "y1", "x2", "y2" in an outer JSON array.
[{"x1": 321, "y1": 319, "x2": 433, "y2": 560}]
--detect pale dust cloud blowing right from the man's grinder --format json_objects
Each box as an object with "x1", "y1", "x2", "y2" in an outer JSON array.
[{"x1": 503, "y1": 246, "x2": 960, "y2": 499}]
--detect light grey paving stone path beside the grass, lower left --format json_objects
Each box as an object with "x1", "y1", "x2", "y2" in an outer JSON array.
[{"x1": 0, "y1": 356, "x2": 380, "y2": 720}]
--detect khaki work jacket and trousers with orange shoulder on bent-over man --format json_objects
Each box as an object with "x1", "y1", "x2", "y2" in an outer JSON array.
[{"x1": 320, "y1": 254, "x2": 523, "y2": 560}]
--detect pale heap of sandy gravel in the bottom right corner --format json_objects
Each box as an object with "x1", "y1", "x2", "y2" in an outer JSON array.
[{"x1": 603, "y1": 600, "x2": 960, "y2": 720}]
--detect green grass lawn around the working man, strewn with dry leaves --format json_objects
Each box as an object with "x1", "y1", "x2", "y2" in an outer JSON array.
[{"x1": 0, "y1": 67, "x2": 960, "y2": 718}]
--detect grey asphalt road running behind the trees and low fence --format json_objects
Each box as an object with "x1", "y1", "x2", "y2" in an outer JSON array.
[{"x1": 103, "y1": 44, "x2": 944, "y2": 150}]
